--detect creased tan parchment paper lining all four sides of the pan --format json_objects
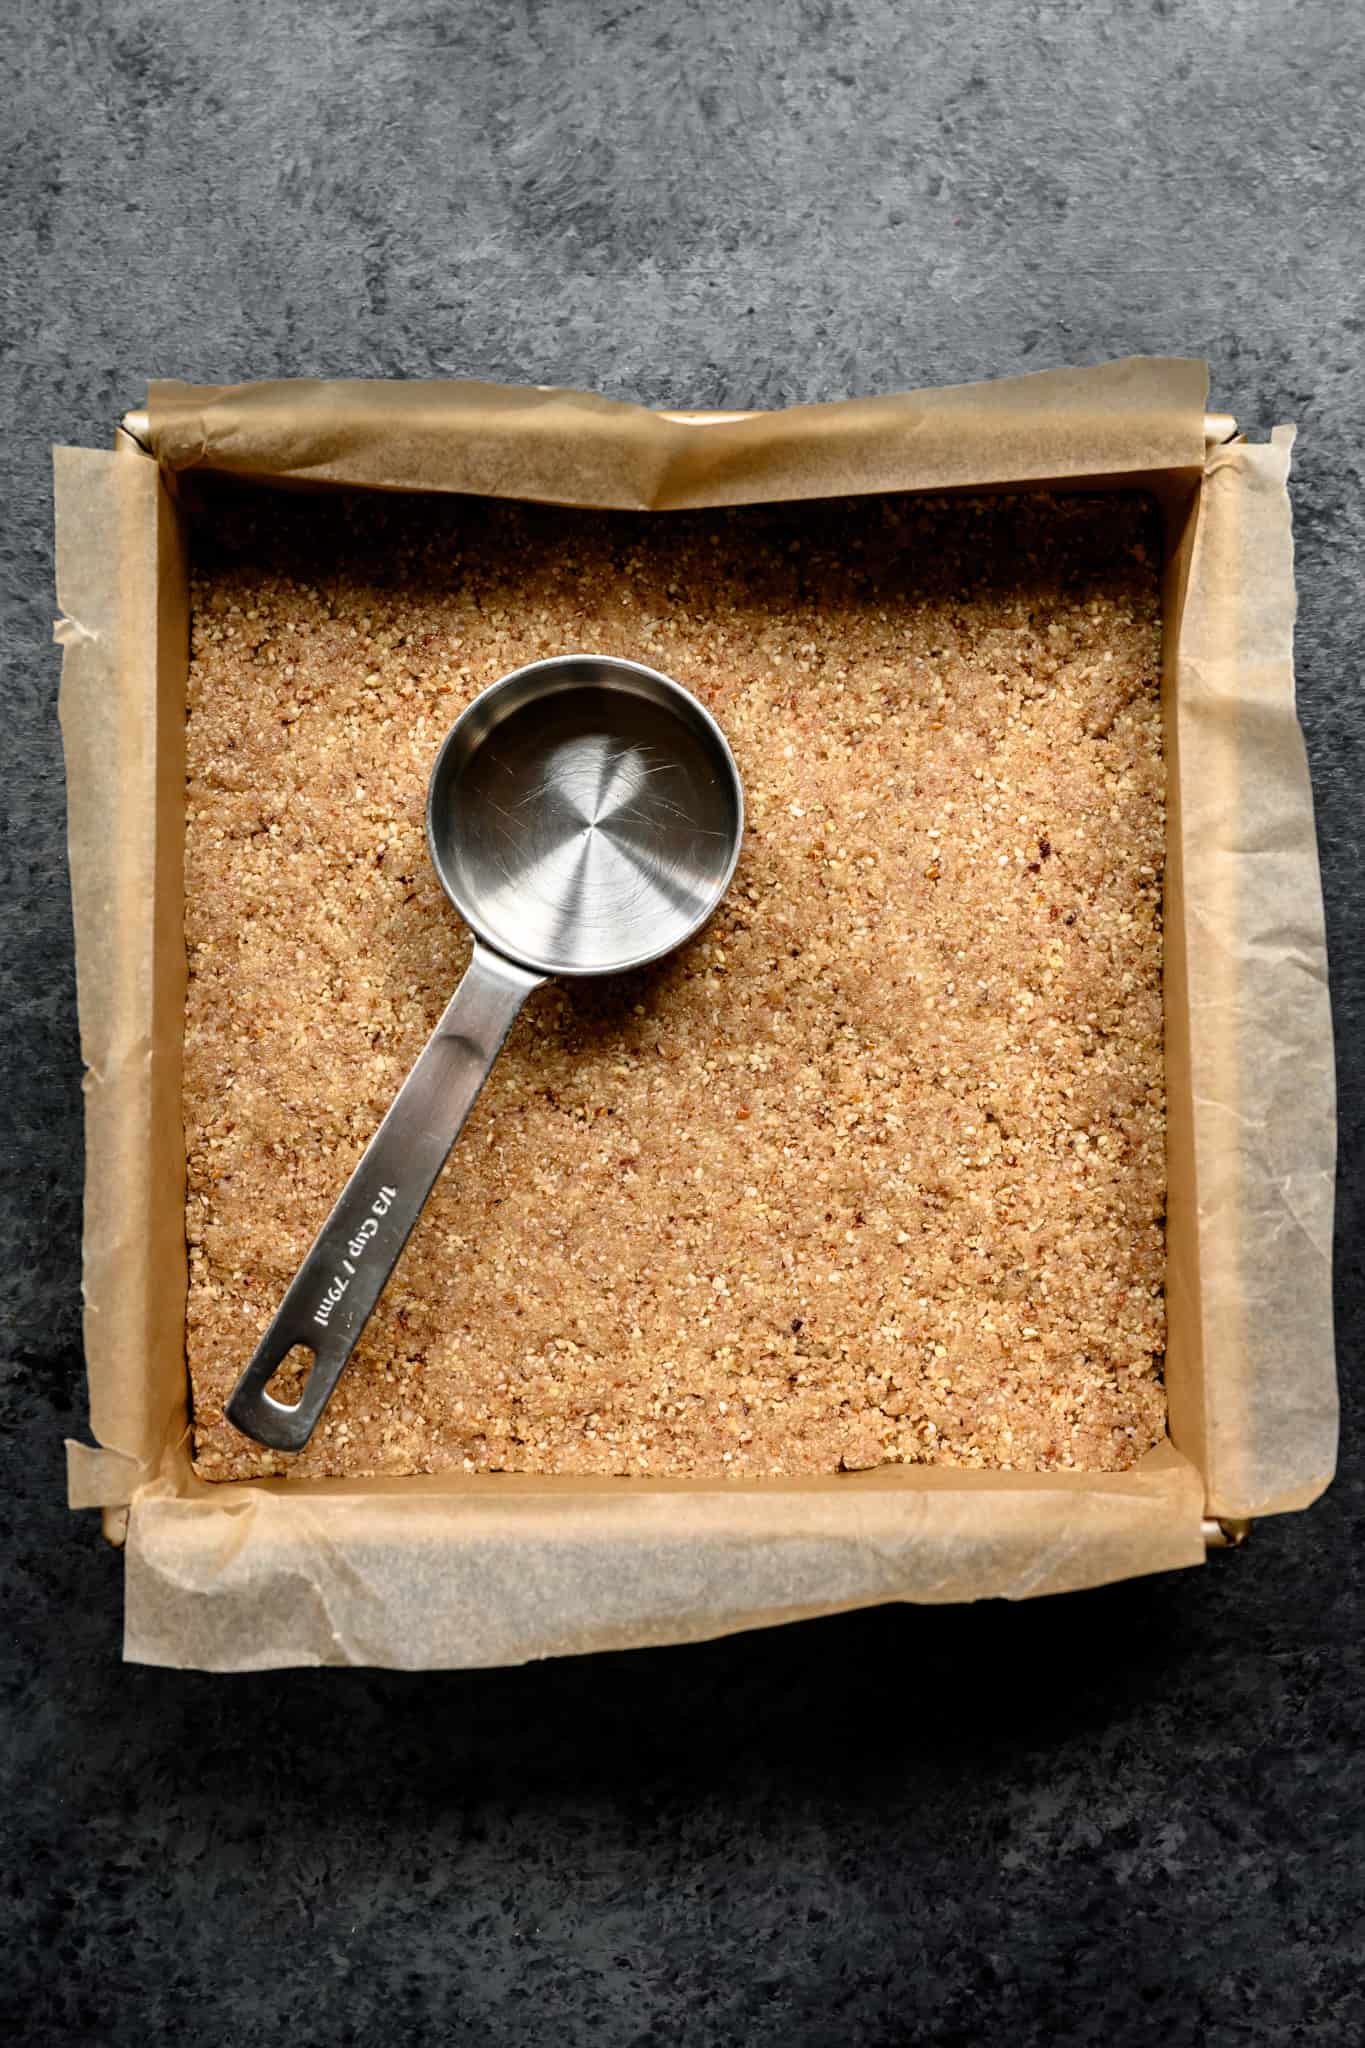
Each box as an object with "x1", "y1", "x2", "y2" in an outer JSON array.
[{"x1": 57, "y1": 360, "x2": 1332, "y2": 1669}]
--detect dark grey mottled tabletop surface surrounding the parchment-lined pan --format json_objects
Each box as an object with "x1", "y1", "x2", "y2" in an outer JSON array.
[{"x1": 0, "y1": 0, "x2": 1365, "y2": 2048}]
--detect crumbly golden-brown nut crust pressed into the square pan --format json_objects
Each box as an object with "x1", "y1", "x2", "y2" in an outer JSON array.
[{"x1": 184, "y1": 487, "x2": 1164, "y2": 1479}]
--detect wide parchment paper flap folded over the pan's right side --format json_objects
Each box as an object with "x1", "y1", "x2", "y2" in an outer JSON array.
[{"x1": 1166, "y1": 426, "x2": 1336, "y2": 1516}]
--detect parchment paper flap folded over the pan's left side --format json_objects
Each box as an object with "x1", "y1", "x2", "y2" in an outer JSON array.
[{"x1": 55, "y1": 449, "x2": 188, "y2": 1540}]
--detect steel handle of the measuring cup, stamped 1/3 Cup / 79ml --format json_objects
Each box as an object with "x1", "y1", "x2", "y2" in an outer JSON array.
[{"x1": 225, "y1": 946, "x2": 544, "y2": 1450}]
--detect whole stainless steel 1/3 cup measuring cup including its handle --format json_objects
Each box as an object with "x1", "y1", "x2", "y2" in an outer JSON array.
[{"x1": 227, "y1": 655, "x2": 745, "y2": 1450}]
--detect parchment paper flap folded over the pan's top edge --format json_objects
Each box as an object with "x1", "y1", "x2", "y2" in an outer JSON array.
[{"x1": 147, "y1": 356, "x2": 1207, "y2": 512}]
